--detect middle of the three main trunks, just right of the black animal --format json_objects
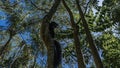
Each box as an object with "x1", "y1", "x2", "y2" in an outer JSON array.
[{"x1": 62, "y1": 0, "x2": 86, "y2": 68}]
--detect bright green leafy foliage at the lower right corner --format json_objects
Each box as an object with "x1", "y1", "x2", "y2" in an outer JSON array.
[{"x1": 99, "y1": 33, "x2": 120, "y2": 68}]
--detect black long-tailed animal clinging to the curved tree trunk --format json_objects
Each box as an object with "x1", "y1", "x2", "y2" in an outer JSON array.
[{"x1": 49, "y1": 22, "x2": 62, "y2": 68}]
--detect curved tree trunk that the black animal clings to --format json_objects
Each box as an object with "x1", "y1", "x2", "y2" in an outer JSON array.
[{"x1": 40, "y1": 0, "x2": 61, "y2": 68}]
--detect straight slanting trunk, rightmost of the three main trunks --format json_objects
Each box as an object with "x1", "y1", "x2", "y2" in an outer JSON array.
[{"x1": 76, "y1": 0, "x2": 103, "y2": 68}]
